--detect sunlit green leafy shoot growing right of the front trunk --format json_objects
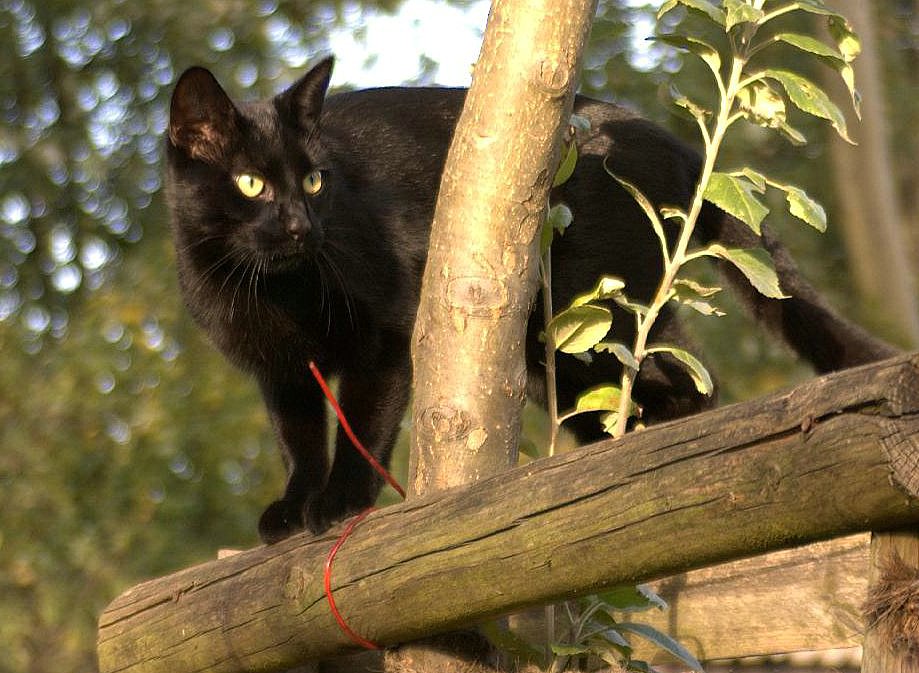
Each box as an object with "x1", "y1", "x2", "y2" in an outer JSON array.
[{"x1": 542, "y1": 0, "x2": 860, "y2": 446}]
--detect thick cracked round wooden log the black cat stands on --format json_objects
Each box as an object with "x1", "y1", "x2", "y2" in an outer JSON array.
[{"x1": 99, "y1": 356, "x2": 919, "y2": 673}]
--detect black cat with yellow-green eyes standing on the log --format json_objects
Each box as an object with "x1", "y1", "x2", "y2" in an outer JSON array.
[{"x1": 167, "y1": 59, "x2": 894, "y2": 542}]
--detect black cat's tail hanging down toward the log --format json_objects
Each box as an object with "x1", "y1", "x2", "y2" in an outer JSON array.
[{"x1": 697, "y1": 203, "x2": 900, "y2": 372}]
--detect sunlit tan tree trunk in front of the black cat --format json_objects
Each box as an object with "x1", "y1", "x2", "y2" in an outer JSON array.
[{"x1": 410, "y1": 0, "x2": 596, "y2": 494}]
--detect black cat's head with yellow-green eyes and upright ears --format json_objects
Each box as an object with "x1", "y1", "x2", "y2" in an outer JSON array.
[{"x1": 167, "y1": 58, "x2": 332, "y2": 272}]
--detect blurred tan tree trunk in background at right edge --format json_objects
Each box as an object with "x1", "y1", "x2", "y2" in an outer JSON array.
[{"x1": 827, "y1": 0, "x2": 919, "y2": 346}]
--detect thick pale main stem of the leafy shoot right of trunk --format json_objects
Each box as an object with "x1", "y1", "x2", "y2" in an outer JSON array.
[{"x1": 613, "y1": 43, "x2": 746, "y2": 437}]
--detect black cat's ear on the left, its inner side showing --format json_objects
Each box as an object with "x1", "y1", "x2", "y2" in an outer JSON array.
[{"x1": 169, "y1": 67, "x2": 239, "y2": 163}]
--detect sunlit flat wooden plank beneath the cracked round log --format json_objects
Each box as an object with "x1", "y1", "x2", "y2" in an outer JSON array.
[{"x1": 639, "y1": 533, "x2": 870, "y2": 660}]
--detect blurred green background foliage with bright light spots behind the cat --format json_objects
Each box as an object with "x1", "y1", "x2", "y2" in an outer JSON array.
[{"x1": 0, "y1": 0, "x2": 919, "y2": 673}]
